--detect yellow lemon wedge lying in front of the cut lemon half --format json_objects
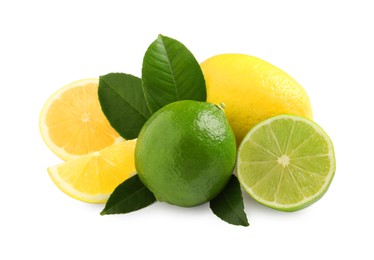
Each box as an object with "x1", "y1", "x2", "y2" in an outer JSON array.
[{"x1": 48, "y1": 140, "x2": 136, "y2": 203}]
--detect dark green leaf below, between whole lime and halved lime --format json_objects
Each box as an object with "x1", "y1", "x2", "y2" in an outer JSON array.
[{"x1": 210, "y1": 175, "x2": 249, "y2": 226}]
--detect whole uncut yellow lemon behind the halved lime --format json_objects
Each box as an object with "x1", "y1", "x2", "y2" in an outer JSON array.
[{"x1": 201, "y1": 54, "x2": 312, "y2": 144}]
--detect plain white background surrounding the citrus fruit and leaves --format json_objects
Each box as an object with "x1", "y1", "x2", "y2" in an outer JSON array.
[{"x1": 0, "y1": 0, "x2": 374, "y2": 259}]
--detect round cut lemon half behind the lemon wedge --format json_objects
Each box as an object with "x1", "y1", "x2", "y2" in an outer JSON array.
[{"x1": 39, "y1": 79, "x2": 123, "y2": 160}]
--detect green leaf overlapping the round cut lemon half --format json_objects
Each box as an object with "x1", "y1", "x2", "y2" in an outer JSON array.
[{"x1": 98, "y1": 73, "x2": 151, "y2": 139}]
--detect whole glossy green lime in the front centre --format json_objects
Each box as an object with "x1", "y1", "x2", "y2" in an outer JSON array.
[{"x1": 135, "y1": 100, "x2": 236, "y2": 207}]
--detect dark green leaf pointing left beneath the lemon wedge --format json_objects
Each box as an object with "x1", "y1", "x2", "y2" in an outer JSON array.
[{"x1": 100, "y1": 174, "x2": 156, "y2": 215}]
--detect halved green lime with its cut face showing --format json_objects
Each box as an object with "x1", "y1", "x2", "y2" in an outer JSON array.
[{"x1": 237, "y1": 115, "x2": 335, "y2": 211}]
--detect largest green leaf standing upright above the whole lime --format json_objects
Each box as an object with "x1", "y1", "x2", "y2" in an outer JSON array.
[{"x1": 142, "y1": 35, "x2": 206, "y2": 113}]
